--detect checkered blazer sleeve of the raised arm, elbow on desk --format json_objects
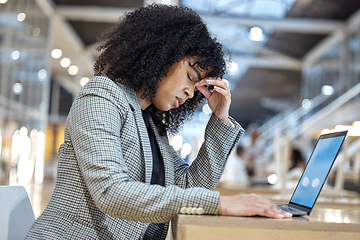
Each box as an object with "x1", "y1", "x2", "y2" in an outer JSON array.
[{"x1": 174, "y1": 114, "x2": 245, "y2": 190}]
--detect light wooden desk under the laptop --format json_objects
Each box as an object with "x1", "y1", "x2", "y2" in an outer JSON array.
[{"x1": 172, "y1": 208, "x2": 360, "y2": 240}]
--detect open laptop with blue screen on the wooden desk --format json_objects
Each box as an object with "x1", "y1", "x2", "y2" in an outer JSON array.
[{"x1": 277, "y1": 131, "x2": 347, "y2": 216}]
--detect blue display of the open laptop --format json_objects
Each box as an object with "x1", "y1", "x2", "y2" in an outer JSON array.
[{"x1": 291, "y1": 136, "x2": 345, "y2": 208}]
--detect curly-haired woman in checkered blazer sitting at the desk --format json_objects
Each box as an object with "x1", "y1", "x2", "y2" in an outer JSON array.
[{"x1": 28, "y1": 5, "x2": 292, "y2": 239}]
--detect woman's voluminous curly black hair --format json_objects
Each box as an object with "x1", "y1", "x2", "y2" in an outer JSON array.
[{"x1": 94, "y1": 4, "x2": 226, "y2": 135}]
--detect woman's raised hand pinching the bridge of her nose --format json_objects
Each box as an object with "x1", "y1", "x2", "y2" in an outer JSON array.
[{"x1": 195, "y1": 78, "x2": 231, "y2": 123}]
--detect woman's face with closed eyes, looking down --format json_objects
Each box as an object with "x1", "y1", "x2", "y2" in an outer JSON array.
[{"x1": 151, "y1": 57, "x2": 207, "y2": 111}]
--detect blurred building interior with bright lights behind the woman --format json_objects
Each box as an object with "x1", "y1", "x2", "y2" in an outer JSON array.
[{"x1": 0, "y1": 0, "x2": 360, "y2": 238}]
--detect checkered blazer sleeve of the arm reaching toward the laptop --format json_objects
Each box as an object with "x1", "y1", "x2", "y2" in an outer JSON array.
[{"x1": 67, "y1": 91, "x2": 219, "y2": 223}]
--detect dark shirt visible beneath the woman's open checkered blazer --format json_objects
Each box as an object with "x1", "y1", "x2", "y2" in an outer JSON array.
[{"x1": 142, "y1": 110, "x2": 165, "y2": 186}]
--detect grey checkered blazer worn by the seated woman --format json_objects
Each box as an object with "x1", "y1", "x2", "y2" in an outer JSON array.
[{"x1": 27, "y1": 77, "x2": 243, "y2": 240}]
